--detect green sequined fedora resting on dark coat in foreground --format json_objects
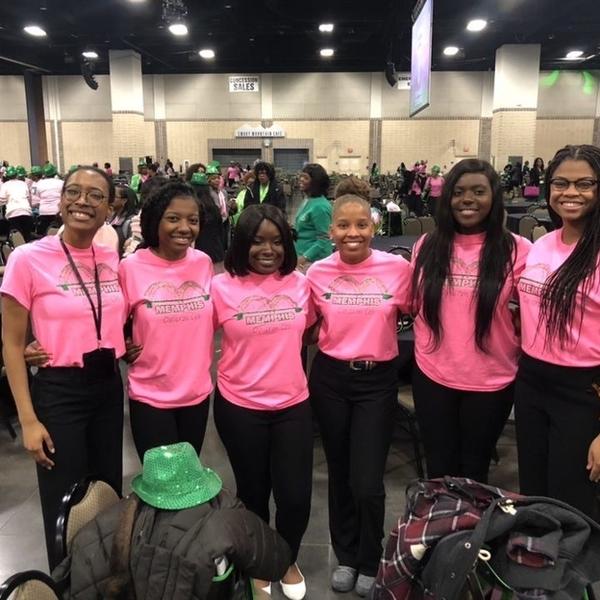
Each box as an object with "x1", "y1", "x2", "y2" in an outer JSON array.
[{"x1": 131, "y1": 442, "x2": 223, "y2": 510}]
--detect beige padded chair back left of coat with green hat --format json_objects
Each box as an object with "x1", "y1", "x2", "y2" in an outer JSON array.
[{"x1": 56, "y1": 478, "x2": 120, "y2": 560}]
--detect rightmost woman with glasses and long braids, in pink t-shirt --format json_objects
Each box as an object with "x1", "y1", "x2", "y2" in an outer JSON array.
[{"x1": 515, "y1": 144, "x2": 600, "y2": 520}]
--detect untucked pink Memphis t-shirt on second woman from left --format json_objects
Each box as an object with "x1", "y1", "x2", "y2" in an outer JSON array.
[{"x1": 119, "y1": 248, "x2": 214, "y2": 408}]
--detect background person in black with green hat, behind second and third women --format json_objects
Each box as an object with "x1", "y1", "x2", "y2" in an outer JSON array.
[{"x1": 190, "y1": 172, "x2": 225, "y2": 273}]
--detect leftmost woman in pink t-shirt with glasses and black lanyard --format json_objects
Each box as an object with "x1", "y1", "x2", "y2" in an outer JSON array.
[{"x1": 0, "y1": 167, "x2": 125, "y2": 569}]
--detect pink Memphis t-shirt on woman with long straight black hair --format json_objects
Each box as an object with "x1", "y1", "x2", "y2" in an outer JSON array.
[{"x1": 413, "y1": 233, "x2": 531, "y2": 392}]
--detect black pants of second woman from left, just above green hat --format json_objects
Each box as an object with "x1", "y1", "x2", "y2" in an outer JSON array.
[{"x1": 129, "y1": 398, "x2": 210, "y2": 462}]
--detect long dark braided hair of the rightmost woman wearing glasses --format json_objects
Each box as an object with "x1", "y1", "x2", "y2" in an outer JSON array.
[{"x1": 540, "y1": 144, "x2": 600, "y2": 346}]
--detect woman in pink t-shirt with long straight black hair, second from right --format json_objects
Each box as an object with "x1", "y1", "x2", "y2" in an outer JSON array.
[{"x1": 412, "y1": 159, "x2": 531, "y2": 482}]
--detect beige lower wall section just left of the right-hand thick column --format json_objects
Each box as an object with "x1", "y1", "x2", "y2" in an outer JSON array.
[{"x1": 381, "y1": 119, "x2": 479, "y2": 172}]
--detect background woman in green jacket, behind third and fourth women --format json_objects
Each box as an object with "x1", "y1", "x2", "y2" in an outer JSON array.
[{"x1": 295, "y1": 163, "x2": 332, "y2": 272}]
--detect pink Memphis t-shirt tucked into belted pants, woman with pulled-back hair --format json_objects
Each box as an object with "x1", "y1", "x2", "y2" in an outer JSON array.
[{"x1": 306, "y1": 250, "x2": 410, "y2": 361}]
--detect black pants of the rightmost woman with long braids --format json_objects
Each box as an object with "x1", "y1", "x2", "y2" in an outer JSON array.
[{"x1": 515, "y1": 355, "x2": 600, "y2": 520}]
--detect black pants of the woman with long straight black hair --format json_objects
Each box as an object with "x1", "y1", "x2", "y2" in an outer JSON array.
[{"x1": 412, "y1": 363, "x2": 514, "y2": 483}]
